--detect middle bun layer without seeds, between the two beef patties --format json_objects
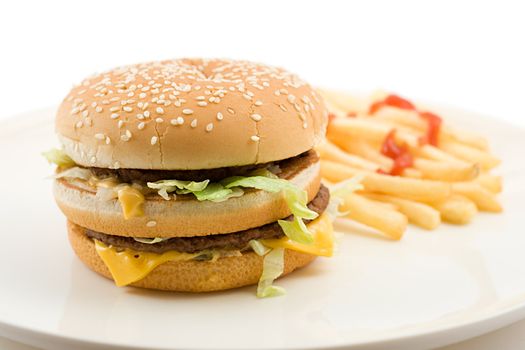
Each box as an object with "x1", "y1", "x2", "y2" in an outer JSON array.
[{"x1": 54, "y1": 156, "x2": 321, "y2": 237}]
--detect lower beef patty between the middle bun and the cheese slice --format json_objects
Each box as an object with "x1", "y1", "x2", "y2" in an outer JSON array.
[{"x1": 85, "y1": 185, "x2": 330, "y2": 254}]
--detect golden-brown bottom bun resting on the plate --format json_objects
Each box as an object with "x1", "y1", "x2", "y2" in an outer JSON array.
[{"x1": 68, "y1": 222, "x2": 316, "y2": 292}]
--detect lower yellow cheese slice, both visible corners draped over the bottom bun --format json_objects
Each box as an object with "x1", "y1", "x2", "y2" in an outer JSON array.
[{"x1": 95, "y1": 214, "x2": 334, "y2": 287}]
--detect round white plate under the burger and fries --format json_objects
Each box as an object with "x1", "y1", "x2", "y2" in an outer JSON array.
[{"x1": 0, "y1": 104, "x2": 525, "y2": 349}]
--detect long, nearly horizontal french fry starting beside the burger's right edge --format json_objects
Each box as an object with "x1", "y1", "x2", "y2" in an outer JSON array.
[{"x1": 321, "y1": 160, "x2": 451, "y2": 202}]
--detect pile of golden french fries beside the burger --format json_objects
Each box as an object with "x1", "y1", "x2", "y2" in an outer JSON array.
[{"x1": 317, "y1": 90, "x2": 502, "y2": 240}]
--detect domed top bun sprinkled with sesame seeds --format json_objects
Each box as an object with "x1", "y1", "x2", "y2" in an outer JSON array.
[{"x1": 56, "y1": 59, "x2": 328, "y2": 170}]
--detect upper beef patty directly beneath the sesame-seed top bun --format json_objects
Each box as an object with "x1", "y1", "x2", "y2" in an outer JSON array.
[{"x1": 89, "y1": 150, "x2": 318, "y2": 183}]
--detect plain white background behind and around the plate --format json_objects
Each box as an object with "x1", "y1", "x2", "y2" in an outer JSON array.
[{"x1": 0, "y1": 0, "x2": 525, "y2": 350}]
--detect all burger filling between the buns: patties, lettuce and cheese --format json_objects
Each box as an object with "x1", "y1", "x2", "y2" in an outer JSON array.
[{"x1": 45, "y1": 150, "x2": 357, "y2": 297}]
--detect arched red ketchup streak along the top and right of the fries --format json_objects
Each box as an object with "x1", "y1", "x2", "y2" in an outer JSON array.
[{"x1": 368, "y1": 95, "x2": 441, "y2": 146}]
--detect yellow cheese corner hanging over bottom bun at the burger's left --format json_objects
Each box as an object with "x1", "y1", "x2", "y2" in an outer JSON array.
[{"x1": 95, "y1": 240, "x2": 199, "y2": 287}]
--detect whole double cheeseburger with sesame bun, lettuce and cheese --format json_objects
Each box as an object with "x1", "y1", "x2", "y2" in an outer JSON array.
[{"x1": 46, "y1": 59, "x2": 333, "y2": 296}]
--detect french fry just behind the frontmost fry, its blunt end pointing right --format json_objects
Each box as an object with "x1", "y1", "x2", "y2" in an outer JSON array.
[{"x1": 365, "y1": 193, "x2": 441, "y2": 230}]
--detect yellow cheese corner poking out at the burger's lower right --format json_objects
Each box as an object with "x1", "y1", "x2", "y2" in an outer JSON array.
[{"x1": 261, "y1": 214, "x2": 334, "y2": 256}]
